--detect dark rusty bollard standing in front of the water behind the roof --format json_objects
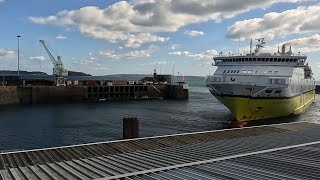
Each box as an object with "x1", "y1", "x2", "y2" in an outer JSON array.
[{"x1": 123, "y1": 117, "x2": 139, "y2": 139}]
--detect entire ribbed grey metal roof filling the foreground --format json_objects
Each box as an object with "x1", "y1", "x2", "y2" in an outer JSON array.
[{"x1": 0, "y1": 123, "x2": 320, "y2": 179}]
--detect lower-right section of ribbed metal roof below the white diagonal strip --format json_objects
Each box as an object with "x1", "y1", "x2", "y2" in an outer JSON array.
[{"x1": 124, "y1": 141, "x2": 320, "y2": 180}]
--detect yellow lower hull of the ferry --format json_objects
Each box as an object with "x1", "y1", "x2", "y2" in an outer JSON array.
[{"x1": 216, "y1": 90, "x2": 315, "y2": 121}]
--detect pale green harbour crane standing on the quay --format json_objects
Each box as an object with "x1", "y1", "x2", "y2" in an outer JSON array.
[{"x1": 39, "y1": 40, "x2": 68, "y2": 86}]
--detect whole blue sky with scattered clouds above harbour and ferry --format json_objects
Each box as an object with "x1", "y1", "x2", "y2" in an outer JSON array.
[{"x1": 0, "y1": 0, "x2": 320, "y2": 79}]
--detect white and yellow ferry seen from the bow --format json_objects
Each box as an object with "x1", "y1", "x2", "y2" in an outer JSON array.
[{"x1": 206, "y1": 38, "x2": 315, "y2": 122}]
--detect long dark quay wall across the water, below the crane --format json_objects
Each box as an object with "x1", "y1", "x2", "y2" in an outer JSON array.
[{"x1": 0, "y1": 84, "x2": 188, "y2": 105}]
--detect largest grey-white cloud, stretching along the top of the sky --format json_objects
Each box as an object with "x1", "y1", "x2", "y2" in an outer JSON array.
[{"x1": 29, "y1": 0, "x2": 308, "y2": 48}]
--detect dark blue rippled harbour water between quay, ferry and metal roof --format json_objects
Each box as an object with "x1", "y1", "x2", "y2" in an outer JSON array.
[{"x1": 0, "y1": 77, "x2": 320, "y2": 150}]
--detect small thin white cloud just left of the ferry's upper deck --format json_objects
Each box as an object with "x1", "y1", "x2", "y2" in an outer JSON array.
[{"x1": 169, "y1": 49, "x2": 218, "y2": 60}]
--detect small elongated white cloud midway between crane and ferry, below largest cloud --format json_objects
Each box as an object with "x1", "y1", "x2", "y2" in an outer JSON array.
[{"x1": 98, "y1": 46, "x2": 156, "y2": 60}]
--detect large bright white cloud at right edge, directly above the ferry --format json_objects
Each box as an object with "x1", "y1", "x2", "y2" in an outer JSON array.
[{"x1": 227, "y1": 5, "x2": 320, "y2": 39}]
